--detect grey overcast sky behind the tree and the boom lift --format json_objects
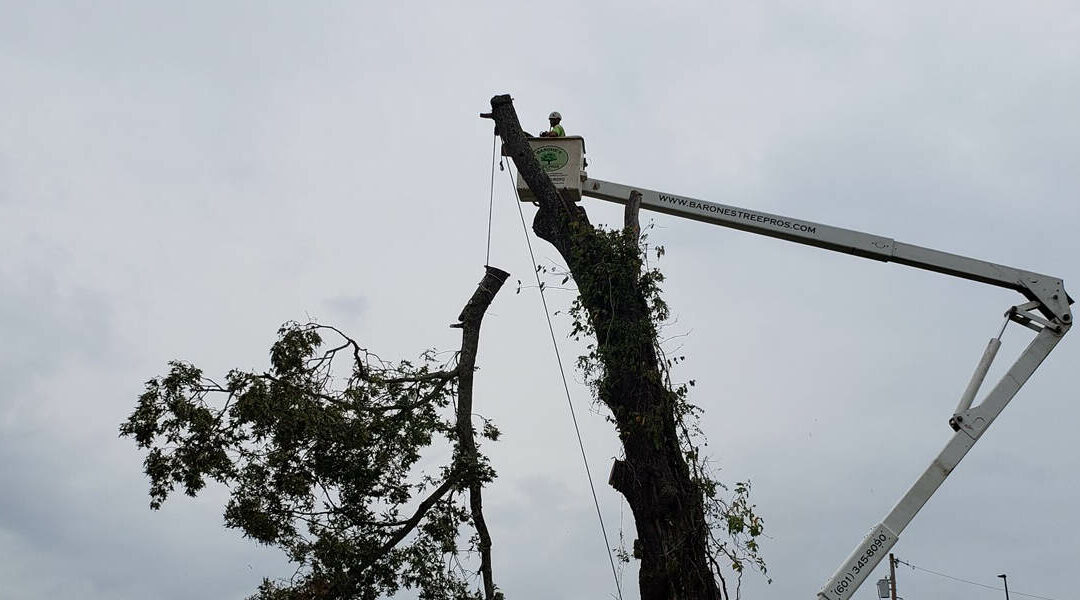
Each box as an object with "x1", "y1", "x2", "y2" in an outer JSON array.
[{"x1": 0, "y1": 0, "x2": 1080, "y2": 600}]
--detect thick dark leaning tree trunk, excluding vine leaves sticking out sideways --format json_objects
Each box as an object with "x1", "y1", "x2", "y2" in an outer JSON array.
[{"x1": 491, "y1": 95, "x2": 719, "y2": 600}]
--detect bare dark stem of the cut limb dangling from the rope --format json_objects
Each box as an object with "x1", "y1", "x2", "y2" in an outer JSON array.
[{"x1": 456, "y1": 267, "x2": 510, "y2": 600}]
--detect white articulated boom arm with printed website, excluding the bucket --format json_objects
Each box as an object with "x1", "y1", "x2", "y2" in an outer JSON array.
[{"x1": 581, "y1": 178, "x2": 1072, "y2": 600}]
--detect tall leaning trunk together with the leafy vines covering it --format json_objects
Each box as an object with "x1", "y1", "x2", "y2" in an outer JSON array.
[{"x1": 485, "y1": 96, "x2": 765, "y2": 600}]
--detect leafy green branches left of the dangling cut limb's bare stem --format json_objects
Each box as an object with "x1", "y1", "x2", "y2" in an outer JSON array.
[{"x1": 120, "y1": 323, "x2": 498, "y2": 600}]
